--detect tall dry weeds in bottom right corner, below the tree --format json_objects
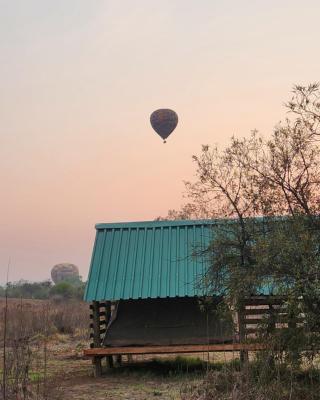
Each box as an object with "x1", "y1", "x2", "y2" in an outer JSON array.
[{"x1": 181, "y1": 360, "x2": 320, "y2": 400}]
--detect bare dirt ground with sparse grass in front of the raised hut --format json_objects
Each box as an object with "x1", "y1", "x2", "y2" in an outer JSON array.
[{"x1": 49, "y1": 341, "x2": 221, "y2": 400}]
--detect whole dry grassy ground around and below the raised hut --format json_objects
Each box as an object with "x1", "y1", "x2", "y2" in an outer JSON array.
[{"x1": 0, "y1": 299, "x2": 320, "y2": 400}]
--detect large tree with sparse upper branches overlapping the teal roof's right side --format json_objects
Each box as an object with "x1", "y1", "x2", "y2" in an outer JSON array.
[{"x1": 168, "y1": 84, "x2": 320, "y2": 361}]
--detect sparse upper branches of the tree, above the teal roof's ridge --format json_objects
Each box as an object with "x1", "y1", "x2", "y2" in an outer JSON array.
[{"x1": 171, "y1": 84, "x2": 320, "y2": 221}]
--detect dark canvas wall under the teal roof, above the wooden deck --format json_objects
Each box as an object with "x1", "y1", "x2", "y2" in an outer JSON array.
[{"x1": 104, "y1": 297, "x2": 236, "y2": 347}]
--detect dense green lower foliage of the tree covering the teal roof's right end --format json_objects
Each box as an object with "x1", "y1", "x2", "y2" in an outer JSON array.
[{"x1": 205, "y1": 215, "x2": 320, "y2": 365}]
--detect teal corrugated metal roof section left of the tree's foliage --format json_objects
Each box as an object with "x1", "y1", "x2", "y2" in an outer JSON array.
[{"x1": 85, "y1": 220, "x2": 213, "y2": 301}]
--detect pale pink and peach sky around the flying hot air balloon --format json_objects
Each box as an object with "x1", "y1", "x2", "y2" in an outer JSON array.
[{"x1": 0, "y1": 0, "x2": 320, "y2": 283}]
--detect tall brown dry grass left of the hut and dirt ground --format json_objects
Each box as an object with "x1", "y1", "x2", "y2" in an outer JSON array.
[{"x1": 0, "y1": 299, "x2": 89, "y2": 400}]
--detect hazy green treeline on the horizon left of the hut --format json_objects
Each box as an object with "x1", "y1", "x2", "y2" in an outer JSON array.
[{"x1": 0, "y1": 279, "x2": 85, "y2": 300}]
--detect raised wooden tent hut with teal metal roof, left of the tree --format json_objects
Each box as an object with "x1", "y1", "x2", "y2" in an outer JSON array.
[{"x1": 85, "y1": 220, "x2": 282, "y2": 375}]
